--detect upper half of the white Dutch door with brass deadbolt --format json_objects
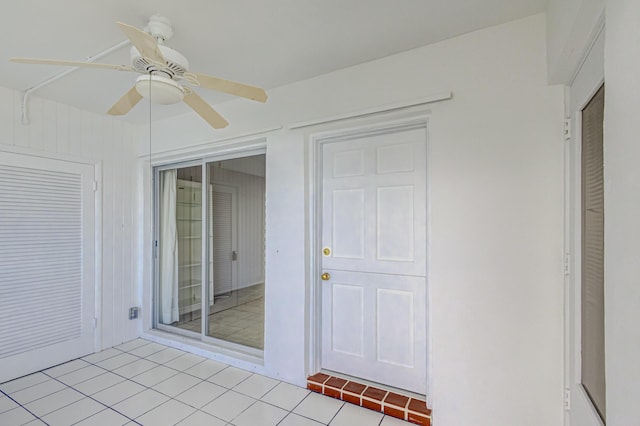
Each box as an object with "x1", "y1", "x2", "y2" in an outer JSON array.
[{"x1": 322, "y1": 129, "x2": 426, "y2": 276}]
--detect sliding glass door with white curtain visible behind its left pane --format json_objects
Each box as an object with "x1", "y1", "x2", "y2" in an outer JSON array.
[{"x1": 154, "y1": 154, "x2": 265, "y2": 350}]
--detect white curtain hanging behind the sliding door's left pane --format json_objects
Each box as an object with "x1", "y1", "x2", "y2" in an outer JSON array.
[{"x1": 159, "y1": 169, "x2": 179, "y2": 324}]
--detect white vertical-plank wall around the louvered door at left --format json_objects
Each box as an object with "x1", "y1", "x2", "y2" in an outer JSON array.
[{"x1": 0, "y1": 87, "x2": 140, "y2": 348}]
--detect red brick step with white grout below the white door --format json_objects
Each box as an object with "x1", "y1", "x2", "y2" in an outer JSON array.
[{"x1": 307, "y1": 372, "x2": 431, "y2": 426}]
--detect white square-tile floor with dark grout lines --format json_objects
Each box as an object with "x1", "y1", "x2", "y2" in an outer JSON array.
[{"x1": 0, "y1": 339, "x2": 408, "y2": 426}]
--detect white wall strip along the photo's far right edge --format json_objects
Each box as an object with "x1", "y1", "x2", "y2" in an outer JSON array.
[{"x1": 604, "y1": 0, "x2": 640, "y2": 426}]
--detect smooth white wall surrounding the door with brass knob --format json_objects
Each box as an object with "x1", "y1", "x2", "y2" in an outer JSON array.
[{"x1": 140, "y1": 15, "x2": 563, "y2": 426}]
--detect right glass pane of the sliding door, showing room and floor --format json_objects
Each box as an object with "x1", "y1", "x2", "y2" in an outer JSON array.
[{"x1": 207, "y1": 155, "x2": 265, "y2": 349}]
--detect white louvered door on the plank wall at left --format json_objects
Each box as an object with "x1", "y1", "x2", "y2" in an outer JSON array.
[{"x1": 0, "y1": 152, "x2": 95, "y2": 382}]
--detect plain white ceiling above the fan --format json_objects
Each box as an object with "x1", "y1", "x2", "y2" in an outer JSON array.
[{"x1": 0, "y1": 0, "x2": 546, "y2": 123}]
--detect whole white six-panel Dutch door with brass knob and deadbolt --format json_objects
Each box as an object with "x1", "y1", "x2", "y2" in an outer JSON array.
[{"x1": 320, "y1": 126, "x2": 427, "y2": 394}]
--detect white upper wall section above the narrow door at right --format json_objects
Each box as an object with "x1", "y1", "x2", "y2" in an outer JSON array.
[{"x1": 547, "y1": 0, "x2": 605, "y2": 84}]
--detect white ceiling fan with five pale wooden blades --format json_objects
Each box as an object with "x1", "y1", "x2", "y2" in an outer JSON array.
[{"x1": 10, "y1": 15, "x2": 267, "y2": 129}]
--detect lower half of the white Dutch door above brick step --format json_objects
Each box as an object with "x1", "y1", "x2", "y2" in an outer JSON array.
[{"x1": 322, "y1": 270, "x2": 426, "y2": 394}]
